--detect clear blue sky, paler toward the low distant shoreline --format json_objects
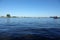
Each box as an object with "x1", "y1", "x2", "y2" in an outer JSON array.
[{"x1": 0, "y1": 0, "x2": 60, "y2": 17}]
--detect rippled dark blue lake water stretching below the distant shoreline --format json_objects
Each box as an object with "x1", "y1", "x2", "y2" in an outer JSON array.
[{"x1": 0, "y1": 18, "x2": 60, "y2": 40}]
